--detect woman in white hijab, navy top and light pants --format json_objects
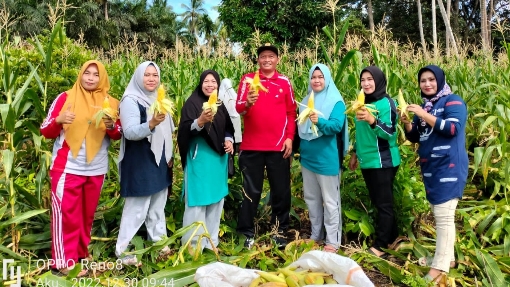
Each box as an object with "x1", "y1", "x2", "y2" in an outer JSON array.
[{"x1": 115, "y1": 61, "x2": 175, "y2": 265}]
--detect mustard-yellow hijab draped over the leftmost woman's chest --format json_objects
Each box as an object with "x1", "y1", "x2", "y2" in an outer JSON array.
[{"x1": 60, "y1": 60, "x2": 119, "y2": 163}]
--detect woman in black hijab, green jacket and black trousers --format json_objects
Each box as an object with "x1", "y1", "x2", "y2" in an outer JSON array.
[{"x1": 349, "y1": 66, "x2": 400, "y2": 257}]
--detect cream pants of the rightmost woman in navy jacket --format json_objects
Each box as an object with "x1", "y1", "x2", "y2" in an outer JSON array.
[{"x1": 430, "y1": 198, "x2": 459, "y2": 272}]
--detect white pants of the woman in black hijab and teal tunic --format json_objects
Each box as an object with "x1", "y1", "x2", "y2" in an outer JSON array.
[{"x1": 182, "y1": 194, "x2": 224, "y2": 253}]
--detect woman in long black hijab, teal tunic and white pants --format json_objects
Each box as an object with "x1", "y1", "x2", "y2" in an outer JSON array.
[{"x1": 177, "y1": 70, "x2": 234, "y2": 252}]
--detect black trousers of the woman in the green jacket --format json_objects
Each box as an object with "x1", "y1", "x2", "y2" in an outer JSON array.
[{"x1": 361, "y1": 166, "x2": 398, "y2": 251}]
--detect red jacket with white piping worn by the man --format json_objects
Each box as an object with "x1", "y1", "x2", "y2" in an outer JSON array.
[{"x1": 236, "y1": 71, "x2": 296, "y2": 151}]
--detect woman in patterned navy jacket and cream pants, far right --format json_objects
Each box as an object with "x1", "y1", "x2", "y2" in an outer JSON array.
[{"x1": 402, "y1": 65, "x2": 468, "y2": 281}]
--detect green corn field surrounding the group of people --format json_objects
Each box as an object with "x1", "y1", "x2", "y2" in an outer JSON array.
[{"x1": 0, "y1": 19, "x2": 510, "y2": 286}]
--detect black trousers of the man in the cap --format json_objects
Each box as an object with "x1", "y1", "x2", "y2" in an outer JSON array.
[{"x1": 237, "y1": 151, "x2": 290, "y2": 237}]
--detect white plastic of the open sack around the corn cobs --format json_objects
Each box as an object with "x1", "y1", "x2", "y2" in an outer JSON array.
[{"x1": 195, "y1": 250, "x2": 374, "y2": 287}]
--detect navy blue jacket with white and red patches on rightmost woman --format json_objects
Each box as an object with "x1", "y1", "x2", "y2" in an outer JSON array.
[{"x1": 406, "y1": 94, "x2": 469, "y2": 205}]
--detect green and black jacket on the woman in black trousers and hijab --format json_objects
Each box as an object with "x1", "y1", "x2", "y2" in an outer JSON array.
[{"x1": 355, "y1": 97, "x2": 400, "y2": 169}]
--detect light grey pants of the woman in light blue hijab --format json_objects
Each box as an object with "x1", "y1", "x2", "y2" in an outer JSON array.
[{"x1": 301, "y1": 167, "x2": 342, "y2": 249}]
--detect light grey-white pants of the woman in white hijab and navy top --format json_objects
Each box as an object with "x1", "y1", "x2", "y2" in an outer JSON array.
[{"x1": 115, "y1": 188, "x2": 168, "y2": 257}]
